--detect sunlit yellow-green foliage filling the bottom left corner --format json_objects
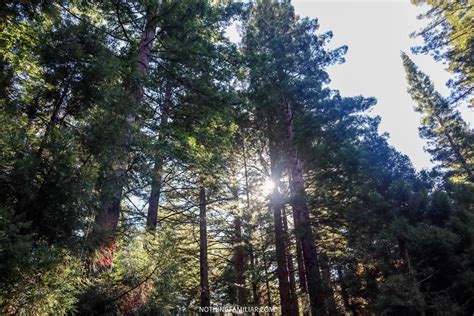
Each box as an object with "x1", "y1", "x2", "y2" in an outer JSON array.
[{"x1": 0, "y1": 209, "x2": 84, "y2": 315}]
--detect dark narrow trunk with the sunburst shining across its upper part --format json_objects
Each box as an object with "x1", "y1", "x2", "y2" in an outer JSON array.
[{"x1": 269, "y1": 138, "x2": 292, "y2": 315}]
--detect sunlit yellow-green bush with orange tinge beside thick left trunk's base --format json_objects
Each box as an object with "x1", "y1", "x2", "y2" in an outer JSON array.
[{"x1": 77, "y1": 229, "x2": 184, "y2": 315}]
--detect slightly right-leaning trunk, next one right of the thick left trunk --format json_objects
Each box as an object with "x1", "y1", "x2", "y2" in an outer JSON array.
[{"x1": 146, "y1": 82, "x2": 172, "y2": 232}]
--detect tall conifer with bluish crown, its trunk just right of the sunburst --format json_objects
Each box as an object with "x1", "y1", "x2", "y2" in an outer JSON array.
[{"x1": 244, "y1": 1, "x2": 345, "y2": 314}]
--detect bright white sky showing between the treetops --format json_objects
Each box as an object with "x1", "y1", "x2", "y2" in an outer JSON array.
[{"x1": 229, "y1": 0, "x2": 474, "y2": 169}]
